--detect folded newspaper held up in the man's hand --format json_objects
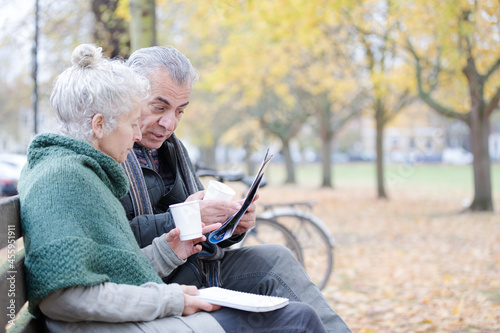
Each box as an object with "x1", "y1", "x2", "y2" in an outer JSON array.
[{"x1": 208, "y1": 148, "x2": 273, "y2": 244}]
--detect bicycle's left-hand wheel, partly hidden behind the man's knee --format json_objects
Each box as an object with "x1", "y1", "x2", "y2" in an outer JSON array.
[{"x1": 238, "y1": 217, "x2": 304, "y2": 265}]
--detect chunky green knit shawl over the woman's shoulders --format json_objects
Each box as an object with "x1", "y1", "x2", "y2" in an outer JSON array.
[{"x1": 18, "y1": 134, "x2": 162, "y2": 315}]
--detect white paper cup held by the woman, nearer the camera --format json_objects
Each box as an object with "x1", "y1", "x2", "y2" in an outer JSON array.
[{"x1": 170, "y1": 200, "x2": 202, "y2": 240}]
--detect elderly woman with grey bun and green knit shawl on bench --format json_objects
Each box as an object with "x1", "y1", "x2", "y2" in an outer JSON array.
[{"x1": 19, "y1": 44, "x2": 325, "y2": 332}]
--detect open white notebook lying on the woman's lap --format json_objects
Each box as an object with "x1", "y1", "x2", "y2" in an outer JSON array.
[{"x1": 196, "y1": 287, "x2": 289, "y2": 312}]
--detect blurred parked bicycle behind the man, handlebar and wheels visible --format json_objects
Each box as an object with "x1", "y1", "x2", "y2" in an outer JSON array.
[{"x1": 197, "y1": 165, "x2": 335, "y2": 289}]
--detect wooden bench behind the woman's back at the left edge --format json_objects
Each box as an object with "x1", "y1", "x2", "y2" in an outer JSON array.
[{"x1": 0, "y1": 196, "x2": 47, "y2": 333}]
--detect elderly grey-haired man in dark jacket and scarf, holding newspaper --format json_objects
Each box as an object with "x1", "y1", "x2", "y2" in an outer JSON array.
[{"x1": 122, "y1": 46, "x2": 350, "y2": 332}]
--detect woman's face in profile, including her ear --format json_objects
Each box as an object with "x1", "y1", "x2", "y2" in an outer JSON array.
[{"x1": 92, "y1": 103, "x2": 142, "y2": 163}]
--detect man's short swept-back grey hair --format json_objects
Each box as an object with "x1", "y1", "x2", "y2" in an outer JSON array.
[{"x1": 127, "y1": 46, "x2": 199, "y2": 88}]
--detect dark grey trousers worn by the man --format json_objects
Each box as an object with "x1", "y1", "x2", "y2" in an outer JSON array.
[{"x1": 168, "y1": 244, "x2": 351, "y2": 333}]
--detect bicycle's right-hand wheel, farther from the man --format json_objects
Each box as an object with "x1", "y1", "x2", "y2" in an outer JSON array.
[{"x1": 261, "y1": 207, "x2": 335, "y2": 289}]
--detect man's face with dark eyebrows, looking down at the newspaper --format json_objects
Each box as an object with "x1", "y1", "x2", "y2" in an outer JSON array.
[{"x1": 139, "y1": 70, "x2": 191, "y2": 149}]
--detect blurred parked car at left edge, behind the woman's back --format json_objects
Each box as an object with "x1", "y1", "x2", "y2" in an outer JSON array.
[{"x1": 0, "y1": 154, "x2": 26, "y2": 197}]
